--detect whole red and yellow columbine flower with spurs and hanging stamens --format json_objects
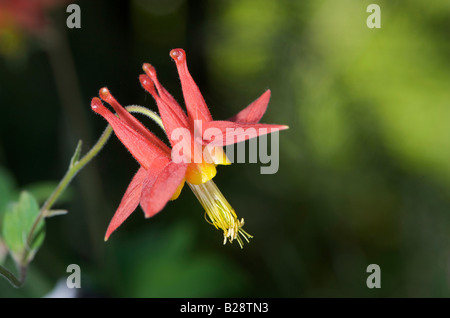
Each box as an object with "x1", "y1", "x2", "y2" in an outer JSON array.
[{"x1": 91, "y1": 49, "x2": 288, "y2": 247}]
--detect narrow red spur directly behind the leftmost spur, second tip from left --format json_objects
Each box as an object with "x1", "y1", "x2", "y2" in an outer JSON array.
[{"x1": 99, "y1": 87, "x2": 168, "y2": 151}]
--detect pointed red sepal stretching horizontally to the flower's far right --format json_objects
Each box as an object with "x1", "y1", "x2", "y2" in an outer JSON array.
[{"x1": 203, "y1": 121, "x2": 289, "y2": 146}]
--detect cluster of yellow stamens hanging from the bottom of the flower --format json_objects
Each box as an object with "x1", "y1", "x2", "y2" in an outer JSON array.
[{"x1": 187, "y1": 180, "x2": 253, "y2": 248}]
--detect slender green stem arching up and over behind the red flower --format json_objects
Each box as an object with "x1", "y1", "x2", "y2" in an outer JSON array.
[{"x1": 0, "y1": 105, "x2": 164, "y2": 287}]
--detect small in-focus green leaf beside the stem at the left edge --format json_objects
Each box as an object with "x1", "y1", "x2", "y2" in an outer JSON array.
[{"x1": 3, "y1": 191, "x2": 45, "y2": 265}]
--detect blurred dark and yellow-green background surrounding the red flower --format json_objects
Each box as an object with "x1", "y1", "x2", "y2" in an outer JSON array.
[{"x1": 0, "y1": 0, "x2": 450, "y2": 297}]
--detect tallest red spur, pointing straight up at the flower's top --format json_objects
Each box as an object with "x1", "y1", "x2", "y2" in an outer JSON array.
[{"x1": 170, "y1": 49, "x2": 212, "y2": 124}]
